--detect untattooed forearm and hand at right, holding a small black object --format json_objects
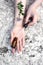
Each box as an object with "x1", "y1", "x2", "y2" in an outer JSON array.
[{"x1": 26, "y1": 0, "x2": 43, "y2": 26}]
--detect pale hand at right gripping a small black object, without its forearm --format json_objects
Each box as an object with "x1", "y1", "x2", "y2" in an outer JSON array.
[{"x1": 25, "y1": 5, "x2": 39, "y2": 25}]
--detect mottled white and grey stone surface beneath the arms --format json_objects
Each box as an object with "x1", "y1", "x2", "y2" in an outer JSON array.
[{"x1": 0, "y1": 0, "x2": 43, "y2": 65}]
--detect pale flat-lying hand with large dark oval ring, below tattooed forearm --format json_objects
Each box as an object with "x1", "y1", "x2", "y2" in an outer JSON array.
[{"x1": 11, "y1": 26, "x2": 25, "y2": 53}]
